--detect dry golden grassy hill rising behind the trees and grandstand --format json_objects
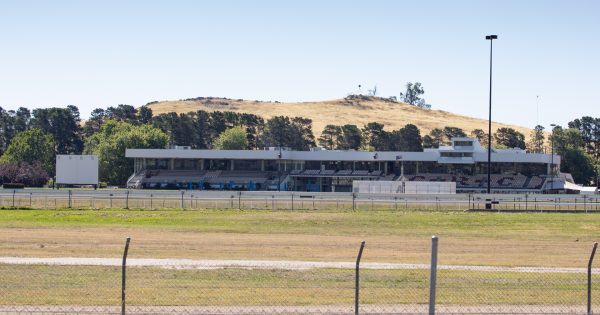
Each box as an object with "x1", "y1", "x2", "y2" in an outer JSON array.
[{"x1": 148, "y1": 96, "x2": 531, "y2": 138}]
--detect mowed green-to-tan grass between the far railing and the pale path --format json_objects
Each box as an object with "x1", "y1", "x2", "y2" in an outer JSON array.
[{"x1": 0, "y1": 209, "x2": 600, "y2": 267}]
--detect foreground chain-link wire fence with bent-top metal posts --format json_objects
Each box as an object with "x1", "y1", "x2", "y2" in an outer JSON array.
[{"x1": 0, "y1": 238, "x2": 600, "y2": 314}]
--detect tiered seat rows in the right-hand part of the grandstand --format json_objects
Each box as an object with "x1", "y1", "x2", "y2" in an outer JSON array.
[{"x1": 405, "y1": 174, "x2": 544, "y2": 190}]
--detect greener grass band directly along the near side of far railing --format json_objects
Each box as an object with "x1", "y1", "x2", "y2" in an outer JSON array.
[{"x1": 0, "y1": 209, "x2": 600, "y2": 240}]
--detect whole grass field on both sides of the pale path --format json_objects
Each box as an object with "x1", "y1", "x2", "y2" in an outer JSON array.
[{"x1": 0, "y1": 209, "x2": 600, "y2": 312}]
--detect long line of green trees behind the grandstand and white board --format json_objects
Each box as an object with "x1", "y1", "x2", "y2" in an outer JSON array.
[{"x1": 0, "y1": 105, "x2": 600, "y2": 188}]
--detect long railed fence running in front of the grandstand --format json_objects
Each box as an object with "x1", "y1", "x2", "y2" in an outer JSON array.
[{"x1": 0, "y1": 189, "x2": 600, "y2": 212}]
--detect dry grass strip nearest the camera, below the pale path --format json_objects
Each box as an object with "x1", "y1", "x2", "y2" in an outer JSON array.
[{"x1": 0, "y1": 265, "x2": 600, "y2": 305}]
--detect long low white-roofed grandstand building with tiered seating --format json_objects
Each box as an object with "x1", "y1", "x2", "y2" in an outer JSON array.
[{"x1": 125, "y1": 138, "x2": 565, "y2": 192}]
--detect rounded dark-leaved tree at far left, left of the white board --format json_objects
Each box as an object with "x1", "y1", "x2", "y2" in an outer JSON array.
[{"x1": 0, "y1": 128, "x2": 54, "y2": 174}]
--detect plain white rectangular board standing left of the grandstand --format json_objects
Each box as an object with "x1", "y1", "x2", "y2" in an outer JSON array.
[{"x1": 56, "y1": 155, "x2": 98, "y2": 186}]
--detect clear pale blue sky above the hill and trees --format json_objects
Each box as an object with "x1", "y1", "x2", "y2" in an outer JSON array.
[{"x1": 0, "y1": 0, "x2": 600, "y2": 128}]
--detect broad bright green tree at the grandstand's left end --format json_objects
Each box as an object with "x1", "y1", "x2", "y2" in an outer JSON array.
[{"x1": 84, "y1": 120, "x2": 169, "y2": 185}]
